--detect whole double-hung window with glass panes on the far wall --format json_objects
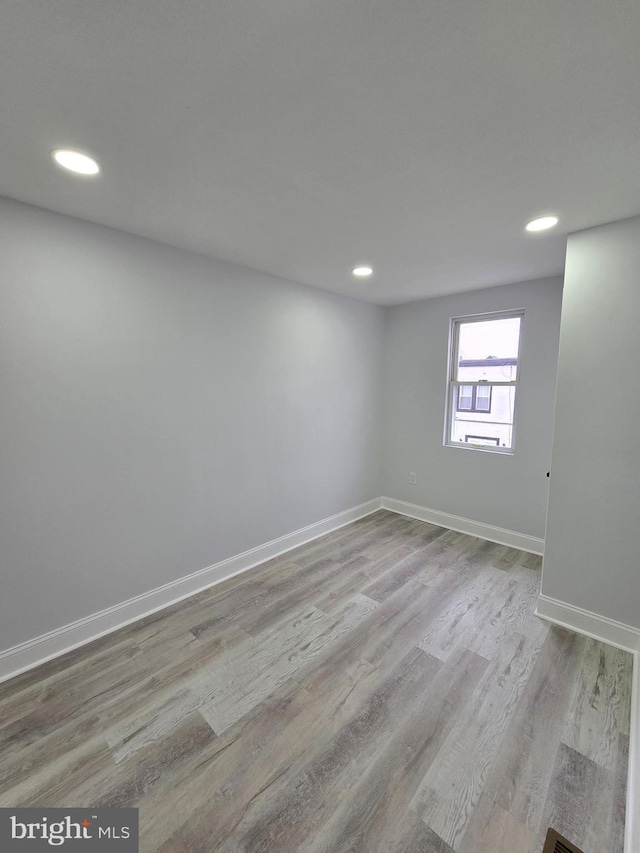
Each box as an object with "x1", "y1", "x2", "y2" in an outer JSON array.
[{"x1": 445, "y1": 311, "x2": 524, "y2": 453}]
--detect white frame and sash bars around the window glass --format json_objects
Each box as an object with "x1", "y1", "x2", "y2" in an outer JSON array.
[{"x1": 443, "y1": 308, "x2": 525, "y2": 456}]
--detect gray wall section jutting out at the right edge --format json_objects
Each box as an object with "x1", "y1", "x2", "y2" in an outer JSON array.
[{"x1": 542, "y1": 218, "x2": 640, "y2": 628}]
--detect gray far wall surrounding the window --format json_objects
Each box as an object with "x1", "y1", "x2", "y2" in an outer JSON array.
[{"x1": 383, "y1": 279, "x2": 562, "y2": 537}]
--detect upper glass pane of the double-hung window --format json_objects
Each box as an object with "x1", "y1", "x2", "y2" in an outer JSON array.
[{"x1": 455, "y1": 317, "x2": 521, "y2": 382}]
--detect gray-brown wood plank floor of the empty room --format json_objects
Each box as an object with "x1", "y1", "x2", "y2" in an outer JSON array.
[{"x1": 0, "y1": 511, "x2": 632, "y2": 853}]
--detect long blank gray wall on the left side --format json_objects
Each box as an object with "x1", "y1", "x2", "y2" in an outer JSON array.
[{"x1": 0, "y1": 200, "x2": 384, "y2": 649}]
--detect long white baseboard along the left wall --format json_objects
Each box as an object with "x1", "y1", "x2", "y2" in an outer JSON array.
[{"x1": 0, "y1": 498, "x2": 382, "y2": 683}]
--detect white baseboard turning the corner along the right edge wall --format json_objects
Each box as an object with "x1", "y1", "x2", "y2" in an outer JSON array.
[{"x1": 536, "y1": 595, "x2": 640, "y2": 853}]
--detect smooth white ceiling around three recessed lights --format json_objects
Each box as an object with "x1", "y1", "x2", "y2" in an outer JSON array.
[{"x1": 0, "y1": 0, "x2": 640, "y2": 304}]
